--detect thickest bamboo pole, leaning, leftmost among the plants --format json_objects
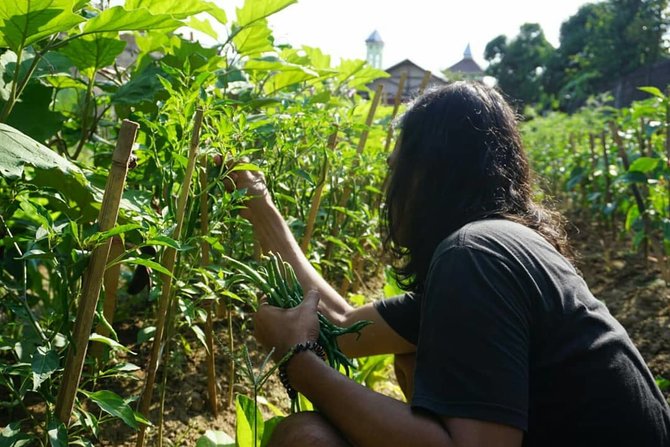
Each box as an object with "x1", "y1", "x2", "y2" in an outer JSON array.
[{"x1": 56, "y1": 120, "x2": 139, "y2": 425}]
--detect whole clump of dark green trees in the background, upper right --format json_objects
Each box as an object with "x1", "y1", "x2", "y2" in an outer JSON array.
[{"x1": 485, "y1": 0, "x2": 669, "y2": 112}]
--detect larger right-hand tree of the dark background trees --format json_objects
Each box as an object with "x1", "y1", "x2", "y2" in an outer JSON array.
[{"x1": 543, "y1": 0, "x2": 668, "y2": 110}]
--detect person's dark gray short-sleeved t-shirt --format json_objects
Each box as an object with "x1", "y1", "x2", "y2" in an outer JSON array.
[{"x1": 376, "y1": 219, "x2": 670, "y2": 447}]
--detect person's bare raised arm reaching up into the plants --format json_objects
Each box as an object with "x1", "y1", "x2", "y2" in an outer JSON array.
[{"x1": 231, "y1": 171, "x2": 416, "y2": 357}]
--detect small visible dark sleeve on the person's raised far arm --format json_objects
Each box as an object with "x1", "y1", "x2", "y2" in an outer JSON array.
[{"x1": 374, "y1": 293, "x2": 420, "y2": 345}]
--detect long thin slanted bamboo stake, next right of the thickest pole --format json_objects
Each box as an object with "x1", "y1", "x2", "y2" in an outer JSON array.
[{"x1": 136, "y1": 108, "x2": 203, "y2": 447}]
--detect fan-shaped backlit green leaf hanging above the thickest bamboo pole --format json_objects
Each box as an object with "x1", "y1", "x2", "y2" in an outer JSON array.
[{"x1": 60, "y1": 33, "x2": 126, "y2": 79}]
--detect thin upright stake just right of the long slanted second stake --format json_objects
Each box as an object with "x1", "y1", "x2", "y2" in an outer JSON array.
[{"x1": 200, "y1": 154, "x2": 219, "y2": 417}]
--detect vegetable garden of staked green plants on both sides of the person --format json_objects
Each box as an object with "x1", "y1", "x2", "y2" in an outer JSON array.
[{"x1": 0, "y1": 0, "x2": 670, "y2": 446}]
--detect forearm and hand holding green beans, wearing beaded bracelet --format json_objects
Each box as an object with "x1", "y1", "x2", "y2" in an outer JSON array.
[{"x1": 254, "y1": 292, "x2": 523, "y2": 447}]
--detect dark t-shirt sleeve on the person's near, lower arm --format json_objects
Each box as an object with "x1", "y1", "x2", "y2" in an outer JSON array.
[{"x1": 412, "y1": 247, "x2": 530, "y2": 430}]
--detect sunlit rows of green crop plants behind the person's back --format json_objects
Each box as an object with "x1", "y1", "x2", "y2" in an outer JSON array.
[{"x1": 523, "y1": 87, "x2": 670, "y2": 257}]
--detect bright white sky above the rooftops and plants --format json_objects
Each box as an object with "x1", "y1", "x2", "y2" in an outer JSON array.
[{"x1": 258, "y1": 0, "x2": 593, "y2": 72}]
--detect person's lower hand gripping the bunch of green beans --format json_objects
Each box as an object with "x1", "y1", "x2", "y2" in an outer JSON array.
[{"x1": 254, "y1": 290, "x2": 320, "y2": 360}]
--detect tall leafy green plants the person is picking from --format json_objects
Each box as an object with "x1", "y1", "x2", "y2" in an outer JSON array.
[{"x1": 0, "y1": 0, "x2": 390, "y2": 445}]
